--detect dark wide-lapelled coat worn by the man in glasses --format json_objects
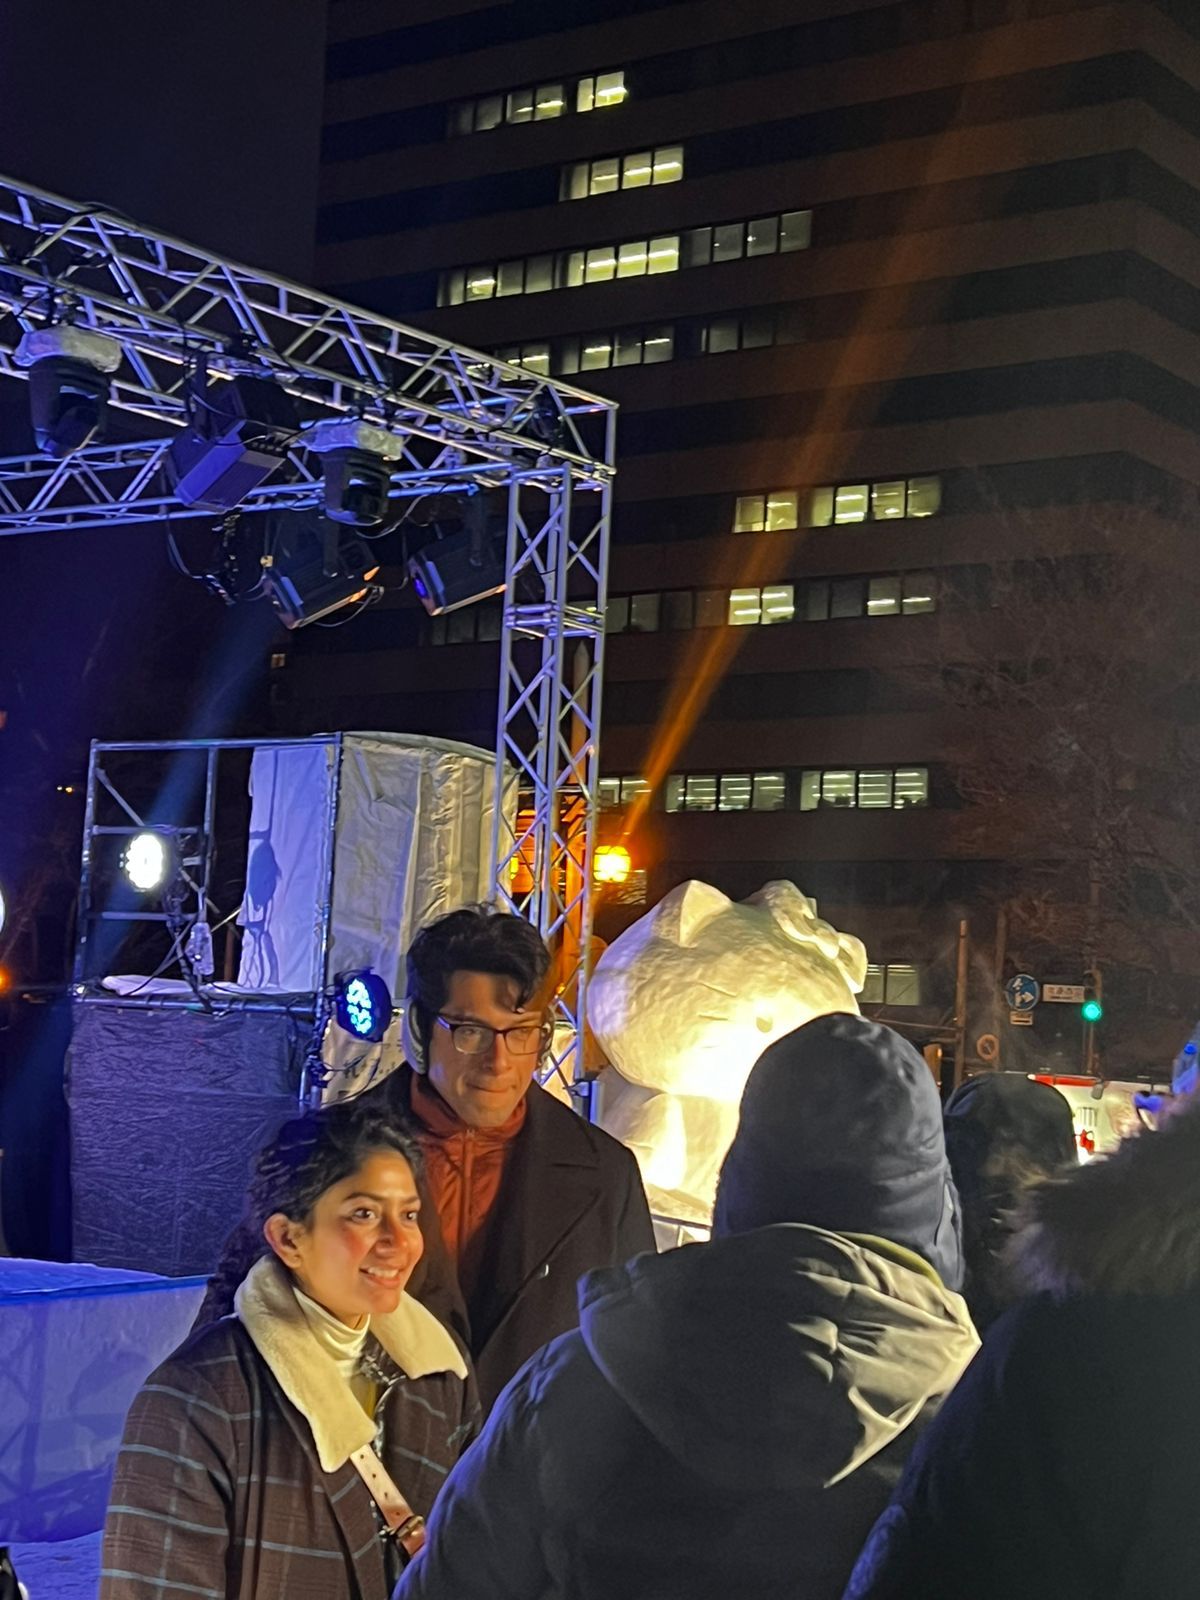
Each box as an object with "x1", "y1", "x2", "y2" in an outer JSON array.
[{"x1": 371, "y1": 1067, "x2": 654, "y2": 1413}]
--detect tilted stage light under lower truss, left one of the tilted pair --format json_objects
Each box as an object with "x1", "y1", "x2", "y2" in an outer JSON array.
[{"x1": 262, "y1": 510, "x2": 384, "y2": 629}]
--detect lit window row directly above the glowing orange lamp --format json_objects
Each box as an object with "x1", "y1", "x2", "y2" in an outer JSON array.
[{"x1": 598, "y1": 766, "x2": 930, "y2": 813}]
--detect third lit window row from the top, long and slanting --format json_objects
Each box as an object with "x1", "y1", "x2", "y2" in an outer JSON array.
[{"x1": 437, "y1": 211, "x2": 813, "y2": 306}]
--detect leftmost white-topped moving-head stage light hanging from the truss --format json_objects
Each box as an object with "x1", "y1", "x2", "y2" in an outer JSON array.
[{"x1": 16, "y1": 322, "x2": 122, "y2": 461}]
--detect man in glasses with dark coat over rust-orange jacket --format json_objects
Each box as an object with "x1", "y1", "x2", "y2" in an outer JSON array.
[{"x1": 368, "y1": 906, "x2": 654, "y2": 1408}]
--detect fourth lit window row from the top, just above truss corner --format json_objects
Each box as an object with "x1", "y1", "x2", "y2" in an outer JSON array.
[{"x1": 496, "y1": 307, "x2": 805, "y2": 378}]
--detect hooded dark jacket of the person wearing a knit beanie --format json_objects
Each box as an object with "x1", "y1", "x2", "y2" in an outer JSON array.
[{"x1": 395, "y1": 1224, "x2": 978, "y2": 1600}]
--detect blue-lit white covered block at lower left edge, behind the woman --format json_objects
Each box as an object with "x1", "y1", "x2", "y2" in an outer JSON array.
[{"x1": 0, "y1": 1261, "x2": 205, "y2": 1544}]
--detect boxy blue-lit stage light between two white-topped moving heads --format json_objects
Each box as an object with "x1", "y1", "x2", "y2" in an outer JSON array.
[{"x1": 166, "y1": 370, "x2": 299, "y2": 510}]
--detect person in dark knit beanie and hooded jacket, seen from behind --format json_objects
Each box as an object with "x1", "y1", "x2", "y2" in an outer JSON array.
[{"x1": 395, "y1": 1014, "x2": 979, "y2": 1600}]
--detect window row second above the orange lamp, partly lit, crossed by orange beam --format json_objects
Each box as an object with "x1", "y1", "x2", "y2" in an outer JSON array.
[{"x1": 605, "y1": 573, "x2": 938, "y2": 634}]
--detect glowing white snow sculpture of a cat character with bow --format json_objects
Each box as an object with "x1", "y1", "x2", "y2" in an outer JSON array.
[{"x1": 587, "y1": 880, "x2": 867, "y2": 1242}]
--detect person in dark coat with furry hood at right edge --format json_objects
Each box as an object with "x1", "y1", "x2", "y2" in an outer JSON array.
[{"x1": 846, "y1": 1102, "x2": 1200, "y2": 1600}]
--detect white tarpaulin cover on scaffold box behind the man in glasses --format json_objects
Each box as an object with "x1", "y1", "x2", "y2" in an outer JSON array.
[{"x1": 238, "y1": 733, "x2": 508, "y2": 1002}]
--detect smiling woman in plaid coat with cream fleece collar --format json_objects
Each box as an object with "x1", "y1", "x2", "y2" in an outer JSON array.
[{"x1": 99, "y1": 1101, "x2": 478, "y2": 1600}]
